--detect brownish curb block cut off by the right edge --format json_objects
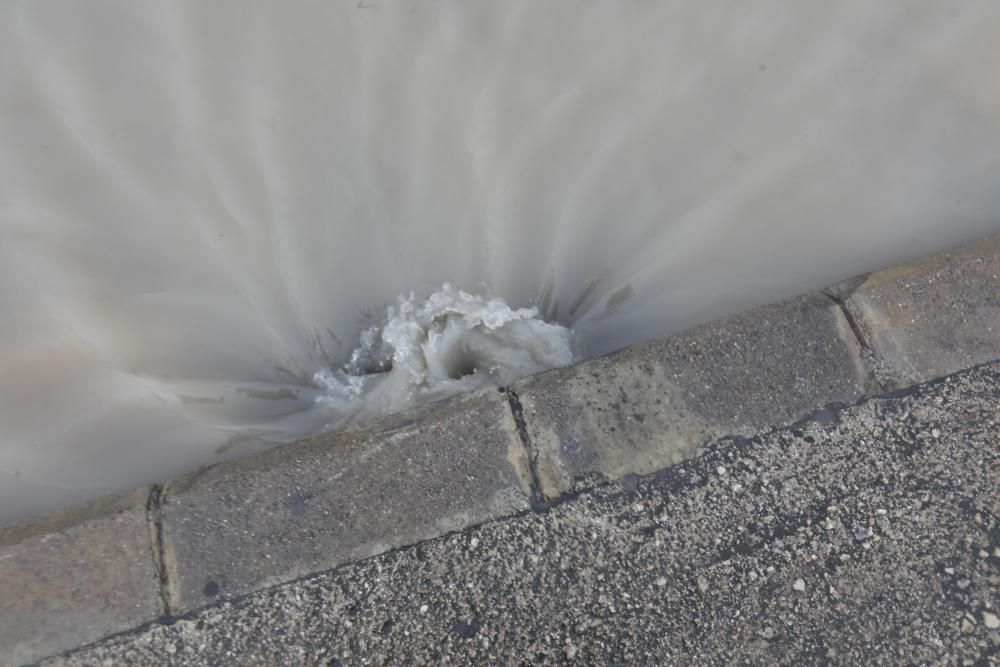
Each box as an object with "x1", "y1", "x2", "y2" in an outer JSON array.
[{"x1": 840, "y1": 235, "x2": 1000, "y2": 387}]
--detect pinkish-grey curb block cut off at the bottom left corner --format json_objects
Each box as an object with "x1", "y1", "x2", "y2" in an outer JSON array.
[{"x1": 0, "y1": 488, "x2": 160, "y2": 665}]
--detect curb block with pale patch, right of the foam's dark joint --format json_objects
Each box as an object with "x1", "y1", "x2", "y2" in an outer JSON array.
[{"x1": 512, "y1": 294, "x2": 867, "y2": 498}]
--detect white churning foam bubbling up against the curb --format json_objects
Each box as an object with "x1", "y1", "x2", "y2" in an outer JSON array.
[{"x1": 314, "y1": 283, "x2": 578, "y2": 428}]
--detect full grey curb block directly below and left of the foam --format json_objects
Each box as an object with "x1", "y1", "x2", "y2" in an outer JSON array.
[{"x1": 161, "y1": 390, "x2": 529, "y2": 612}]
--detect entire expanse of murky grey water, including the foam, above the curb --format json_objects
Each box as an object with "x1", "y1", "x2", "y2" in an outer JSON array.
[{"x1": 0, "y1": 0, "x2": 1000, "y2": 522}]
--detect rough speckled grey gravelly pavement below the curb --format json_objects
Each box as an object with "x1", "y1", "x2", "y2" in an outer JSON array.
[{"x1": 47, "y1": 364, "x2": 1000, "y2": 665}]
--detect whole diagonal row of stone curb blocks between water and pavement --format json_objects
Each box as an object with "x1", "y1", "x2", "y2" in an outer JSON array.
[{"x1": 0, "y1": 235, "x2": 1000, "y2": 665}]
